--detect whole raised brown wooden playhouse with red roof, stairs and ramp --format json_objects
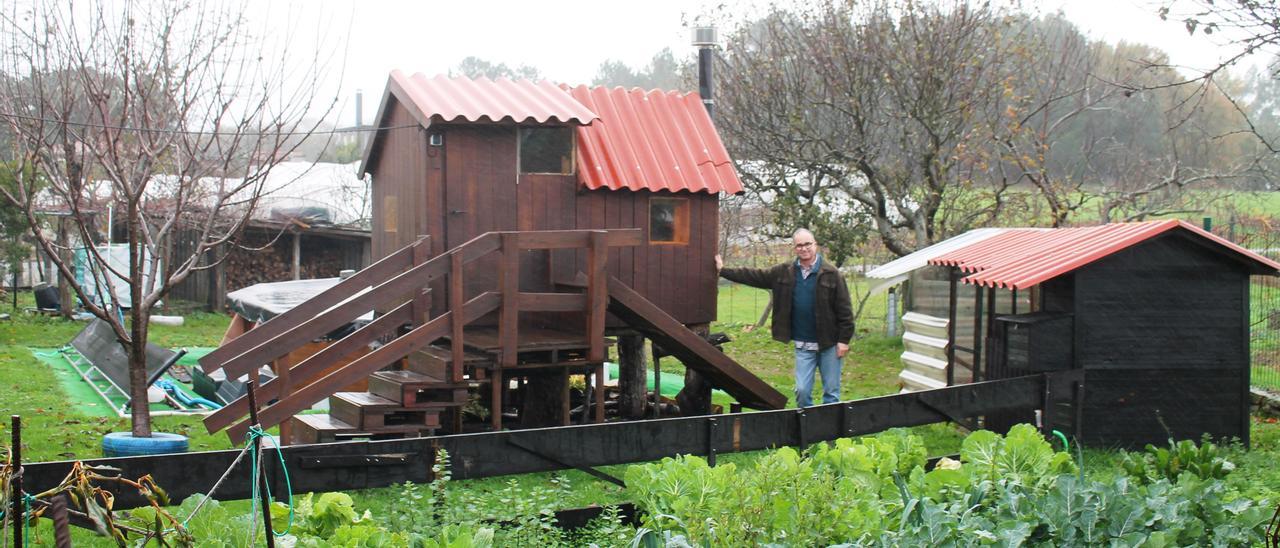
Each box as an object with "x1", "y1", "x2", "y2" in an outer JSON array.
[{"x1": 201, "y1": 72, "x2": 786, "y2": 443}]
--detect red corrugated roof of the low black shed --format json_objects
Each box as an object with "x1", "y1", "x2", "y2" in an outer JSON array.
[{"x1": 929, "y1": 220, "x2": 1280, "y2": 289}]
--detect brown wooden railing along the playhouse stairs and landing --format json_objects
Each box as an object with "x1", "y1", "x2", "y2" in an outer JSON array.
[{"x1": 200, "y1": 229, "x2": 643, "y2": 442}]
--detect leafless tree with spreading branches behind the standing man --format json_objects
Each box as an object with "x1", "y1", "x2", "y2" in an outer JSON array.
[{"x1": 717, "y1": 1, "x2": 1029, "y2": 255}]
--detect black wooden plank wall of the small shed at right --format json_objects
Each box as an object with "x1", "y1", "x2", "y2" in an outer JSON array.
[{"x1": 1059, "y1": 233, "x2": 1249, "y2": 447}]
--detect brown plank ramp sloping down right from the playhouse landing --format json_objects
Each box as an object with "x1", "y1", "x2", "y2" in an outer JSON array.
[{"x1": 609, "y1": 277, "x2": 787, "y2": 410}]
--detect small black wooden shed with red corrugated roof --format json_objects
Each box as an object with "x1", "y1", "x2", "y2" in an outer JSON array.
[{"x1": 928, "y1": 220, "x2": 1280, "y2": 447}]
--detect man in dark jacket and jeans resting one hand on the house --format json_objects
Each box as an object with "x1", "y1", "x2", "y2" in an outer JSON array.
[{"x1": 716, "y1": 228, "x2": 854, "y2": 407}]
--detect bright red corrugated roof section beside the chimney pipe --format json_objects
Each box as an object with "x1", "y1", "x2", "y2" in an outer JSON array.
[{"x1": 566, "y1": 86, "x2": 742, "y2": 193}]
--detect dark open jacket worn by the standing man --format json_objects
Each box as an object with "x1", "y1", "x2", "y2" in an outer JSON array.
[{"x1": 721, "y1": 261, "x2": 854, "y2": 350}]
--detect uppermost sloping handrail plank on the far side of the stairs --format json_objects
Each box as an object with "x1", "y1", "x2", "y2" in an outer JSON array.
[{"x1": 200, "y1": 238, "x2": 430, "y2": 373}]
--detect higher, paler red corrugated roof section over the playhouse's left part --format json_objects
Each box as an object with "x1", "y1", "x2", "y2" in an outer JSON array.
[{"x1": 390, "y1": 70, "x2": 598, "y2": 124}]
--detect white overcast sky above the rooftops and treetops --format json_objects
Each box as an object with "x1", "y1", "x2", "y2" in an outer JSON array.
[{"x1": 246, "y1": 0, "x2": 1259, "y2": 125}]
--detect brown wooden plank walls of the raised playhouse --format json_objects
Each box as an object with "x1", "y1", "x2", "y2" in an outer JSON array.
[{"x1": 369, "y1": 112, "x2": 719, "y2": 324}]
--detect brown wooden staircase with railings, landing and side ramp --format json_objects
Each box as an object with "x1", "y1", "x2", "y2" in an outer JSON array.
[{"x1": 200, "y1": 229, "x2": 786, "y2": 443}]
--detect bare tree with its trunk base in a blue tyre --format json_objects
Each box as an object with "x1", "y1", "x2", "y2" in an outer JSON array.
[{"x1": 0, "y1": 1, "x2": 334, "y2": 437}]
